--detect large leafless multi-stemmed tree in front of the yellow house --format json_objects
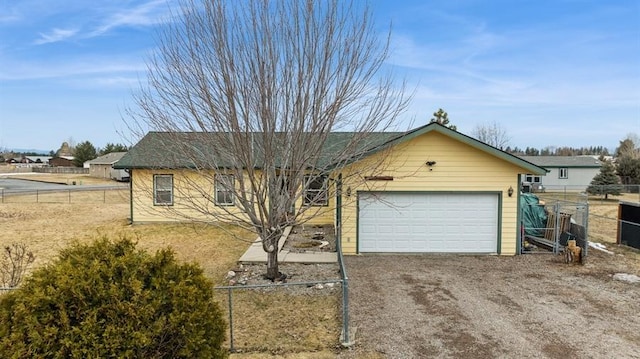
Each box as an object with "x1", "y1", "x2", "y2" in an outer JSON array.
[{"x1": 130, "y1": 0, "x2": 408, "y2": 279}]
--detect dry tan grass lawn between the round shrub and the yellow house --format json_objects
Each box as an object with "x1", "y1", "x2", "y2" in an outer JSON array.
[{"x1": 0, "y1": 196, "x2": 341, "y2": 358}]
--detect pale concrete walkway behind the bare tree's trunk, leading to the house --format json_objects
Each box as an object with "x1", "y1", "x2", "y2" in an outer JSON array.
[{"x1": 238, "y1": 227, "x2": 338, "y2": 264}]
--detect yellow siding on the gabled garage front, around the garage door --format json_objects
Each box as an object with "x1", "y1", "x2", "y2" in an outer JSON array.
[{"x1": 342, "y1": 131, "x2": 523, "y2": 255}]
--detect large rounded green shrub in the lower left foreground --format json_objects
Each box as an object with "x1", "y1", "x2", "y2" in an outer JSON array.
[{"x1": 0, "y1": 238, "x2": 227, "y2": 358}]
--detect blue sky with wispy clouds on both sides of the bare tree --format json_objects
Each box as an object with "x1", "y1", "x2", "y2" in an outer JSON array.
[{"x1": 0, "y1": 0, "x2": 640, "y2": 151}]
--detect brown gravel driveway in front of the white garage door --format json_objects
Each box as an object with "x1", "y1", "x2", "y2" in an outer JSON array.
[{"x1": 340, "y1": 251, "x2": 640, "y2": 359}]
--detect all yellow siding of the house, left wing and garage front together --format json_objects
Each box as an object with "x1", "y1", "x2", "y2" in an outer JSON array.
[{"x1": 131, "y1": 131, "x2": 526, "y2": 255}]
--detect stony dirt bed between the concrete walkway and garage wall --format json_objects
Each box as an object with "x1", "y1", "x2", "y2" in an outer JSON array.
[{"x1": 282, "y1": 224, "x2": 336, "y2": 253}]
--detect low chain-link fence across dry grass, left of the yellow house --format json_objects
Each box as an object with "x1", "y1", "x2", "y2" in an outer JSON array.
[{"x1": 0, "y1": 185, "x2": 129, "y2": 203}]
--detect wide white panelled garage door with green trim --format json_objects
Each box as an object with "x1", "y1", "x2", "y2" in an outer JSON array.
[{"x1": 358, "y1": 192, "x2": 498, "y2": 253}]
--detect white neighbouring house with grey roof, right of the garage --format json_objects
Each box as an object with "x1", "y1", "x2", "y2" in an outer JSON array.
[{"x1": 520, "y1": 156, "x2": 602, "y2": 192}]
